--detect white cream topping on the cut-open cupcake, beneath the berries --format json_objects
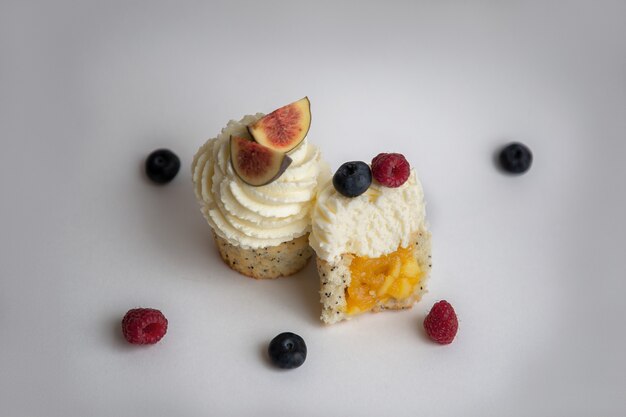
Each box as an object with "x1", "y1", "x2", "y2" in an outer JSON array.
[{"x1": 309, "y1": 170, "x2": 426, "y2": 262}]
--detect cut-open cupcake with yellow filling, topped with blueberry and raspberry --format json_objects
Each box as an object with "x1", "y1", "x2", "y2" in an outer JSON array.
[{"x1": 309, "y1": 154, "x2": 431, "y2": 324}]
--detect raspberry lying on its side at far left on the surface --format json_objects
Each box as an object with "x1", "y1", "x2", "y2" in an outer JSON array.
[{"x1": 122, "y1": 308, "x2": 167, "y2": 345}]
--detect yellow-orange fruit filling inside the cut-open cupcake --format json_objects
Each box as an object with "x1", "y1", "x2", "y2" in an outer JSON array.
[{"x1": 346, "y1": 242, "x2": 424, "y2": 314}]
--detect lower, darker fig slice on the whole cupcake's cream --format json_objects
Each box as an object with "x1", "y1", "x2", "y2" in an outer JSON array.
[{"x1": 230, "y1": 136, "x2": 291, "y2": 187}]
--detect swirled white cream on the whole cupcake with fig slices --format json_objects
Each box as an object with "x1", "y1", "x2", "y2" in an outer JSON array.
[{"x1": 191, "y1": 113, "x2": 329, "y2": 249}]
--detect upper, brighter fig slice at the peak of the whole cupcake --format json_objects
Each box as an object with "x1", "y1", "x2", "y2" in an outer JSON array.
[{"x1": 248, "y1": 97, "x2": 311, "y2": 153}]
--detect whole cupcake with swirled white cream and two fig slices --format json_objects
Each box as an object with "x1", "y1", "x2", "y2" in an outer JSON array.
[{"x1": 192, "y1": 98, "x2": 329, "y2": 278}]
